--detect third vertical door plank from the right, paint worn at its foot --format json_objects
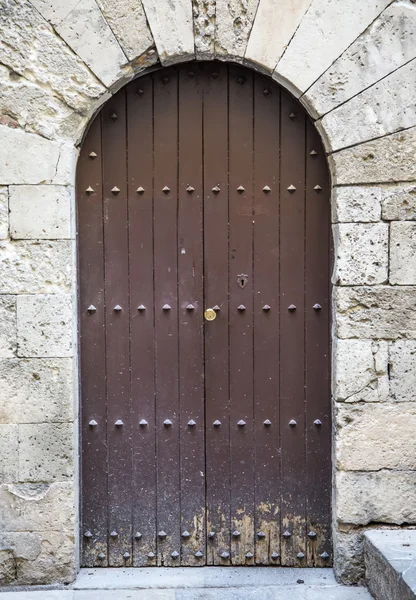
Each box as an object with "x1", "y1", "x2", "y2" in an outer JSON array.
[{"x1": 254, "y1": 75, "x2": 280, "y2": 565}]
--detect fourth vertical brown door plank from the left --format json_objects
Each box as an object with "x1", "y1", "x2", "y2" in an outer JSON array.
[{"x1": 154, "y1": 69, "x2": 181, "y2": 566}]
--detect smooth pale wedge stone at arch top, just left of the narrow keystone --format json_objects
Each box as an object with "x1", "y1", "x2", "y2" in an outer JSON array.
[{"x1": 142, "y1": 0, "x2": 195, "y2": 65}]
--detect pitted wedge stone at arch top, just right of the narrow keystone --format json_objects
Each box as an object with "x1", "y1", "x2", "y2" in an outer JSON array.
[{"x1": 215, "y1": 0, "x2": 259, "y2": 62}]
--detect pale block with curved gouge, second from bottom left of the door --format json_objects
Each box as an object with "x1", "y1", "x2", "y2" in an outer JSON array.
[{"x1": 0, "y1": 482, "x2": 75, "y2": 534}]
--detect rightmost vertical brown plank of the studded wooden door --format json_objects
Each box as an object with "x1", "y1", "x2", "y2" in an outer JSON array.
[{"x1": 305, "y1": 119, "x2": 332, "y2": 567}]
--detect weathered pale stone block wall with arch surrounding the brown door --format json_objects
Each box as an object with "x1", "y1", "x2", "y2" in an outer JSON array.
[{"x1": 0, "y1": 0, "x2": 416, "y2": 584}]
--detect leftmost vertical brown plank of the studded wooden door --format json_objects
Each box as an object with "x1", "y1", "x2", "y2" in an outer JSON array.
[{"x1": 77, "y1": 115, "x2": 108, "y2": 567}]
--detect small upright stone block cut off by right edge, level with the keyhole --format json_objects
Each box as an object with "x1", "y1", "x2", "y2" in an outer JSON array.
[{"x1": 390, "y1": 223, "x2": 416, "y2": 285}]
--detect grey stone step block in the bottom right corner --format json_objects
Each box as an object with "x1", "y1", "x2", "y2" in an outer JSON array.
[{"x1": 364, "y1": 529, "x2": 416, "y2": 600}]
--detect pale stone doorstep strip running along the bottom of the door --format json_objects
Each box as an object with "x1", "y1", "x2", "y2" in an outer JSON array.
[{"x1": 0, "y1": 567, "x2": 374, "y2": 600}]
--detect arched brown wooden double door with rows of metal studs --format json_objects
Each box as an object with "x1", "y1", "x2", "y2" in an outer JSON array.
[{"x1": 77, "y1": 63, "x2": 331, "y2": 566}]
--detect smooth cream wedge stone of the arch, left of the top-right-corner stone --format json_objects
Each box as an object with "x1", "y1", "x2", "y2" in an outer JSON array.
[{"x1": 274, "y1": 0, "x2": 391, "y2": 95}]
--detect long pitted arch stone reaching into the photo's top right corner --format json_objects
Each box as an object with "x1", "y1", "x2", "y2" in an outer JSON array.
[{"x1": 305, "y1": 0, "x2": 416, "y2": 115}]
